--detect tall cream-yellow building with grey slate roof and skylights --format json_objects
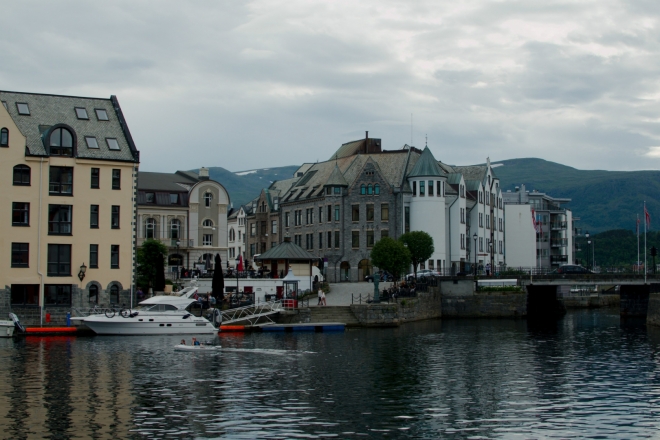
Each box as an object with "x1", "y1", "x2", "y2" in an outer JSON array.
[{"x1": 0, "y1": 91, "x2": 139, "y2": 323}]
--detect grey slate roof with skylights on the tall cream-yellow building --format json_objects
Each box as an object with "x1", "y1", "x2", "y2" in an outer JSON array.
[{"x1": 0, "y1": 91, "x2": 140, "y2": 162}]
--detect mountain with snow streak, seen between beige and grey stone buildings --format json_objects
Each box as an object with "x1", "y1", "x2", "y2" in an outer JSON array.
[{"x1": 206, "y1": 165, "x2": 300, "y2": 208}]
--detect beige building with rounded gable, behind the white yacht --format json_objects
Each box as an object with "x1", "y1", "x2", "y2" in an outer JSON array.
[{"x1": 137, "y1": 168, "x2": 230, "y2": 279}]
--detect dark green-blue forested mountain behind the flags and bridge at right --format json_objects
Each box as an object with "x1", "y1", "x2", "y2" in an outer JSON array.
[{"x1": 493, "y1": 158, "x2": 660, "y2": 233}]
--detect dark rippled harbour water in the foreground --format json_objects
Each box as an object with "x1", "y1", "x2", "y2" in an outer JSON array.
[{"x1": 0, "y1": 309, "x2": 660, "y2": 439}]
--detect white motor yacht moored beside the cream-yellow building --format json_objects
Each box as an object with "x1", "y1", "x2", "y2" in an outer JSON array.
[{"x1": 78, "y1": 287, "x2": 221, "y2": 335}]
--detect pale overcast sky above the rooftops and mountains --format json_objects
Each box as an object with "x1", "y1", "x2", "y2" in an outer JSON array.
[{"x1": 0, "y1": 0, "x2": 660, "y2": 172}]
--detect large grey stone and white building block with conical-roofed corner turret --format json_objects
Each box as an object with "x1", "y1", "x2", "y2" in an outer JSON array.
[{"x1": 247, "y1": 134, "x2": 504, "y2": 282}]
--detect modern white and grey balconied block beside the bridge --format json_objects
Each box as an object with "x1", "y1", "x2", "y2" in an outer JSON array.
[{"x1": 503, "y1": 185, "x2": 576, "y2": 269}]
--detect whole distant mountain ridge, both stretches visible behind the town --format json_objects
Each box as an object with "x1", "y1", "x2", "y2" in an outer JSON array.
[{"x1": 201, "y1": 158, "x2": 660, "y2": 233}]
